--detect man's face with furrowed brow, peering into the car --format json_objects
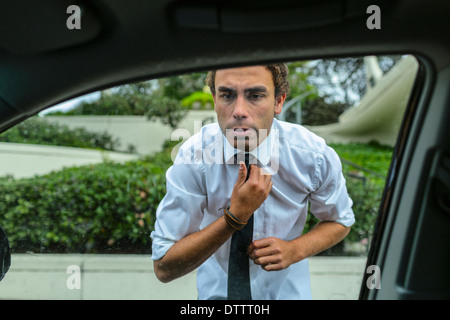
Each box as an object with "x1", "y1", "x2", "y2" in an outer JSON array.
[{"x1": 214, "y1": 66, "x2": 286, "y2": 151}]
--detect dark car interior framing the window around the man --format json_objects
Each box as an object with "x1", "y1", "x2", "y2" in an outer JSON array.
[{"x1": 0, "y1": 0, "x2": 450, "y2": 300}]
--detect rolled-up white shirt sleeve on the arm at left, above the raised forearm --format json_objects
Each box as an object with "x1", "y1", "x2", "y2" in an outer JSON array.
[{"x1": 151, "y1": 162, "x2": 206, "y2": 260}]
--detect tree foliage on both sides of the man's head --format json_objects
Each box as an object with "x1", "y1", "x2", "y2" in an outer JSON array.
[{"x1": 45, "y1": 56, "x2": 401, "y2": 129}]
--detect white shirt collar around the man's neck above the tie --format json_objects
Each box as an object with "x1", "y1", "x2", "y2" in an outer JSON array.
[{"x1": 222, "y1": 119, "x2": 276, "y2": 166}]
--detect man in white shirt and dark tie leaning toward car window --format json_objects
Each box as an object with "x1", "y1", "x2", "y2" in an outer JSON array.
[{"x1": 152, "y1": 64, "x2": 354, "y2": 299}]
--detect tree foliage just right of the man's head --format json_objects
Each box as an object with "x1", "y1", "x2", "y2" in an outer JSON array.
[{"x1": 286, "y1": 56, "x2": 401, "y2": 125}]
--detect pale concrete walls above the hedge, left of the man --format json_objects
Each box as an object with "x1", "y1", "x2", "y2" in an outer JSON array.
[{"x1": 0, "y1": 110, "x2": 217, "y2": 178}]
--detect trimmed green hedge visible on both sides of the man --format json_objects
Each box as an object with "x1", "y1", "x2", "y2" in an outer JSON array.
[{"x1": 0, "y1": 143, "x2": 392, "y2": 253}]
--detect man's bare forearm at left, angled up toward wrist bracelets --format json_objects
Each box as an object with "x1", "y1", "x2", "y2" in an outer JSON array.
[{"x1": 154, "y1": 217, "x2": 235, "y2": 282}]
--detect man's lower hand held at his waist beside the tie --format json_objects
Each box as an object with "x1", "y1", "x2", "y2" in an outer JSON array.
[{"x1": 247, "y1": 237, "x2": 296, "y2": 271}]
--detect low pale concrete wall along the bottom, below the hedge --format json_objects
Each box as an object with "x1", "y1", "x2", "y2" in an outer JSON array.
[{"x1": 0, "y1": 254, "x2": 366, "y2": 300}]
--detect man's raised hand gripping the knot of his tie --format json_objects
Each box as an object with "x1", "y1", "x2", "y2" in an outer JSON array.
[{"x1": 230, "y1": 162, "x2": 273, "y2": 221}]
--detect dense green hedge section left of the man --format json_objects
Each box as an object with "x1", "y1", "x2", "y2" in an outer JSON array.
[{"x1": 0, "y1": 154, "x2": 170, "y2": 253}]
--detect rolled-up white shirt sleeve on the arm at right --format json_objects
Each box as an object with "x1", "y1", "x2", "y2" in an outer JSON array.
[{"x1": 310, "y1": 147, "x2": 355, "y2": 227}]
